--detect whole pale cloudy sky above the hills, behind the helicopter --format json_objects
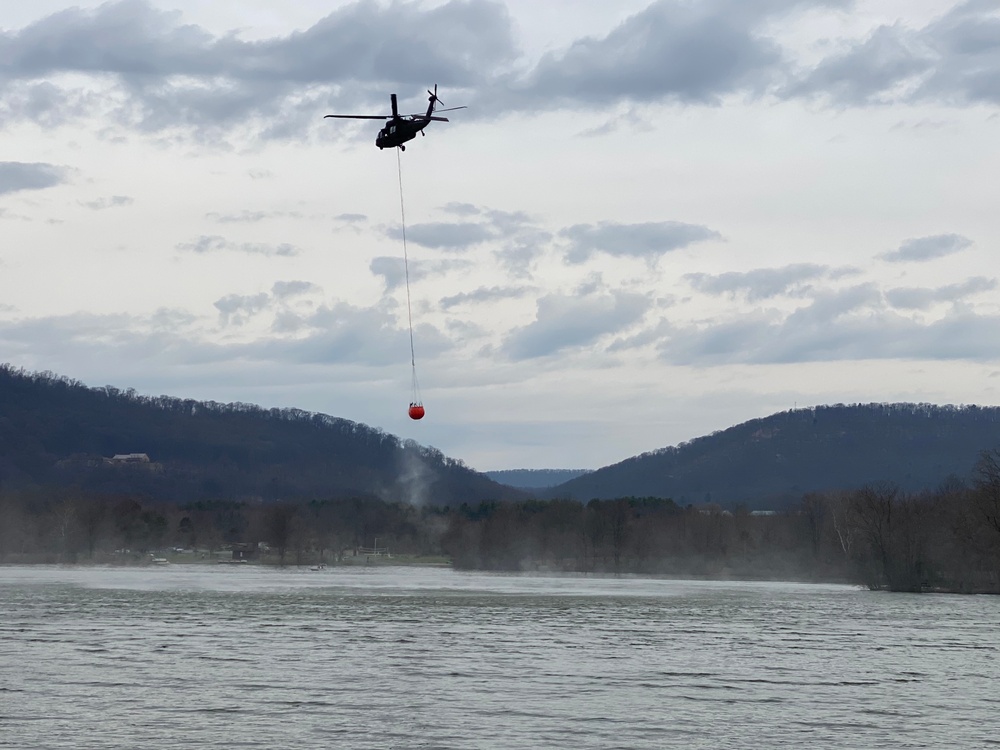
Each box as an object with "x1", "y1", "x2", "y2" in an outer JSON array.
[{"x1": 0, "y1": 0, "x2": 1000, "y2": 471}]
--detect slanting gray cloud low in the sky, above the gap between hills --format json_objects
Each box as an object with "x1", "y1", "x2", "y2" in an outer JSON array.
[{"x1": 502, "y1": 292, "x2": 650, "y2": 360}]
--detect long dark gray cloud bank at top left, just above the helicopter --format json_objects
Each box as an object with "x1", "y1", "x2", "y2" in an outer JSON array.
[{"x1": 0, "y1": 0, "x2": 516, "y2": 140}]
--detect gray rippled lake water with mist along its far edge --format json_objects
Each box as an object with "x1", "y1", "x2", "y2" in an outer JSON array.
[{"x1": 0, "y1": 566, "x2": 1000, "y2": 750}]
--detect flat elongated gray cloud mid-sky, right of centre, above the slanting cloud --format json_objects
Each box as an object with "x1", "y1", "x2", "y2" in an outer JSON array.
[{"x1": 559, "y1": 221, "x2": 722, "y2": 263}]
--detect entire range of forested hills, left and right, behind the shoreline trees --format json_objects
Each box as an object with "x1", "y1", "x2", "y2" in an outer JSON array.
[{"x1": 0, "y1": 365, "x2": 1000, "y2": 509}]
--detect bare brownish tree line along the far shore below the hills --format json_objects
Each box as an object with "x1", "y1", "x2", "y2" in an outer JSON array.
[{"x1": 0, "y1": 450, "x2": 1000, "y2": 593}]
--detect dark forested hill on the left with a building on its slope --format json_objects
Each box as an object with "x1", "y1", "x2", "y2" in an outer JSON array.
[{"x1": 0, "y1": 365, "x2": 518, "y2": 505}]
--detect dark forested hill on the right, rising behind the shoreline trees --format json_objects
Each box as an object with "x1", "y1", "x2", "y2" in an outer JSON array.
[{"x1": 546, "y1": 404, "x2": 1000, "y2": 509}]
